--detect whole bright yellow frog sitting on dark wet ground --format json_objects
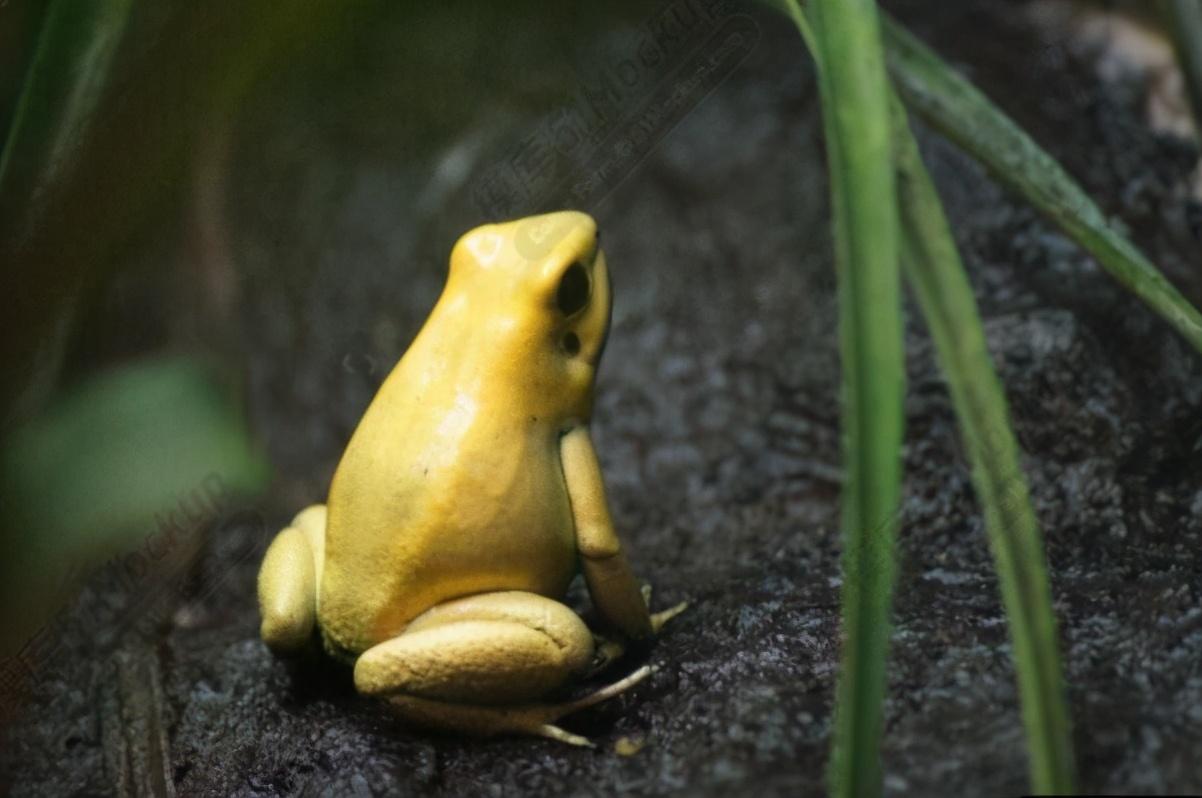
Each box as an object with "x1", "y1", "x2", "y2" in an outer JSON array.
[{"x1": 258, "y1": 212, "x2": 684, "y2": 744}]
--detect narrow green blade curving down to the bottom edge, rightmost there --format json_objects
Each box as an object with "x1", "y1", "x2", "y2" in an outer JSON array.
[{"x1": 893, "y1": 95, "x2": 1073, "y2": 794}]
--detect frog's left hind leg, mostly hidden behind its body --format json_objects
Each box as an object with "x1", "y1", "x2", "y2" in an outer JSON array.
[{"x1": 258, "y1": 505, "x2": 326, "y2": 655}]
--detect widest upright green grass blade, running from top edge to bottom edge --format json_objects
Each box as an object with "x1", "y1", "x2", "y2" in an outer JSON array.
[{"x1": 789, "y1": 0, "x2": 904, "y2": 797}]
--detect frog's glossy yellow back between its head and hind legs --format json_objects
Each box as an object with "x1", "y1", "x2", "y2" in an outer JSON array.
[{"x1": 319, "y1": 337, "x2": 576, "y2": 654}]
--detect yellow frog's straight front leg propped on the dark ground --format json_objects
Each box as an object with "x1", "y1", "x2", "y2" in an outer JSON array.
[{"x1": 560, "y1": 427, "x2": 688, "y2": 666}]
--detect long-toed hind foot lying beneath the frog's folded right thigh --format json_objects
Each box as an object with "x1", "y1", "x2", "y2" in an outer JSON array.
[{"x1": 388, "y1": 665, "x2": 655, "y2": 748}]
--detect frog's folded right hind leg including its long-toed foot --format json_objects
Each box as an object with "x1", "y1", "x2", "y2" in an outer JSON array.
[{"x1": 355, "y1": 591, "x2": 650, "y2": 745}]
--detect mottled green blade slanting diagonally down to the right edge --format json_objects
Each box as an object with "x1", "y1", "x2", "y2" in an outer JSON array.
[{"x1": 882, "y1": 18, "x2": 1202, "y2": 352}]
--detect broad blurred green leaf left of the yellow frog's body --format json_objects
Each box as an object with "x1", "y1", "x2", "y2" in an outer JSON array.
[{"x1": 0, "y1": 359, "x2": 268, "y2": 642}]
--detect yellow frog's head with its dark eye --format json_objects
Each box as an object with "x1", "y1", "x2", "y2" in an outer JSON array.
[{"x1": 445, "y1": 210, "x2": 613, "y2": 420}]
